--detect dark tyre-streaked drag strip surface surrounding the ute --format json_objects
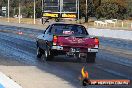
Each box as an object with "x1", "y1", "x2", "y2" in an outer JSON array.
[{"x1": 0, "y1": 25, "x2": 132, "y2": 88}]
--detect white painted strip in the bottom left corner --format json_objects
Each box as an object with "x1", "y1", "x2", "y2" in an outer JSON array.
[{"x1": 0, "y1": 72, "x2": 22, "y2": 88}]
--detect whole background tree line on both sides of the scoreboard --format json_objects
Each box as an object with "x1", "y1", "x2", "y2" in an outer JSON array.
[{"x1": 0, "y1": 0, "x2": 132, "y2": 19}]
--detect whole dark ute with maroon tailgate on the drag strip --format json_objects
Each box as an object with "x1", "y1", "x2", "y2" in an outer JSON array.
[{"x1": 36, "y1": 23, "x2": 99, "y2": 63}]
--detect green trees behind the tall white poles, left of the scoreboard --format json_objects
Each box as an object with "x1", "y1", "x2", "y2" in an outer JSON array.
[{"x1": 0, "y1": 0, "x2": 42, "y2": 17}]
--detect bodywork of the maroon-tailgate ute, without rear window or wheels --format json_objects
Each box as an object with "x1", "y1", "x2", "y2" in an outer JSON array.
[{"x1": 37, "y1": 23, "x2": 99, "y2": 53}]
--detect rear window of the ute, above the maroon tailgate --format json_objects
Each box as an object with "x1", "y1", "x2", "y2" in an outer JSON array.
[{"x1": 50, "y1": 24, "x2": 88, "y2": 35}]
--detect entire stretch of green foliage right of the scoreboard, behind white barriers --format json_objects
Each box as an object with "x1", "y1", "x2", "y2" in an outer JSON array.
[{"x1": 81, "y1": 0, "x2": 132, "y2": 19}]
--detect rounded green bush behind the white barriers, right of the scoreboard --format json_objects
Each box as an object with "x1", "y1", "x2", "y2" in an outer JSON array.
[{"x1": 96, "y1": 2, "x2": 127, "y2": 19}]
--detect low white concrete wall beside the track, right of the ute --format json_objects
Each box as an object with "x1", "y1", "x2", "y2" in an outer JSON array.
[{"x1": 88, "y1": 28, "x2": 132, "y2": 40}]
